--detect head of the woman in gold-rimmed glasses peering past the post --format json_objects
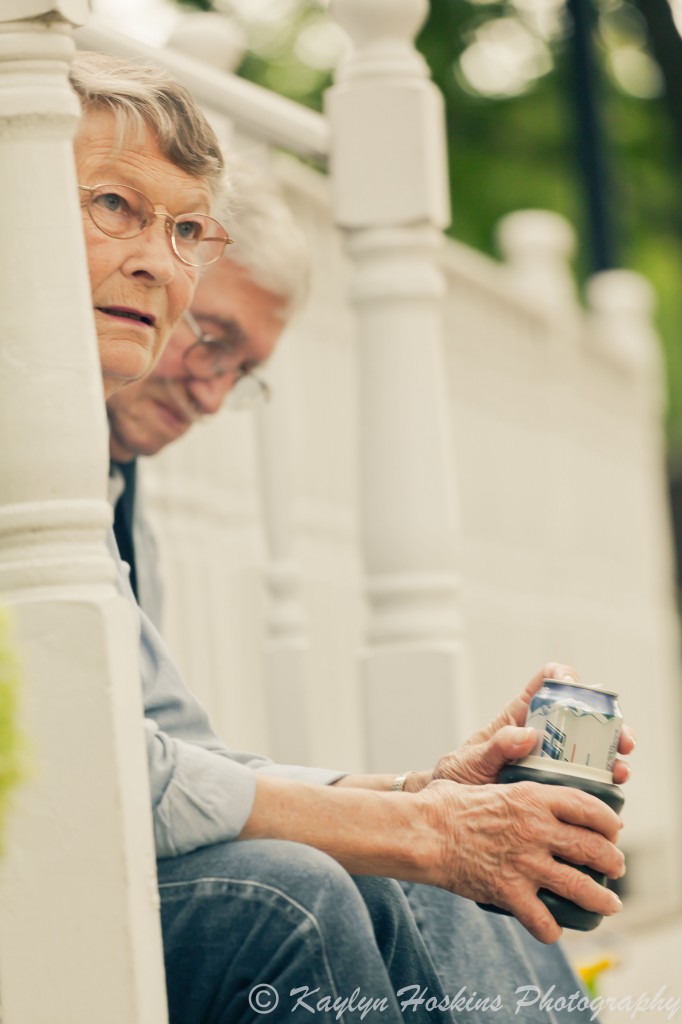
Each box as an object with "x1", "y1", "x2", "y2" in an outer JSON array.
[{"x1": 71, "y1": 54, "x2": 229, "y2": 397}]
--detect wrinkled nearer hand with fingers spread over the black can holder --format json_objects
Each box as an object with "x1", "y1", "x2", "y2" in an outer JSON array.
[{"x1": 418, "y1": 781, "x2": 625, "y2": 942}]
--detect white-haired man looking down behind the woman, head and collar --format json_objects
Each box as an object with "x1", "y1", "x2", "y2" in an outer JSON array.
[{"x1": 108, "y1": 159, "x2": 301, "y2": 626}]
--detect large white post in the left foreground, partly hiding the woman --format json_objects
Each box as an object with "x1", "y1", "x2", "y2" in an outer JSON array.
[{"x1": 0, "y1": 8, "x2": 167, "y2": 1024}]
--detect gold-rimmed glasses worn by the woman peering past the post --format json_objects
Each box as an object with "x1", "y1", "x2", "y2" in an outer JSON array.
[{"x1": 78, "y1": 185, "x2": 232, "y2": 266}]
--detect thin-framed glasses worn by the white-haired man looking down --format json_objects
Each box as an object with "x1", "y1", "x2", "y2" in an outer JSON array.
[{"x1": 182, "y1": 310, "x2": 270, "y2": 410}]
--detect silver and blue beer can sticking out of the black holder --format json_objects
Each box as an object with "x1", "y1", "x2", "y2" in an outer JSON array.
[{"x1": 525, "y1": 679, "x2": 623, "y2": 772}]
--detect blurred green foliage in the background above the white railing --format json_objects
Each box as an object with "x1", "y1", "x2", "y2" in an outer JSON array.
[{"x1": 173, "y1": 0, "x2": 682, "y2": 456}]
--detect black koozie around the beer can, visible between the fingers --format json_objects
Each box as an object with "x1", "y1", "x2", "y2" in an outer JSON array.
[{"x1": 478, "y1": 765, "x2": 625, "y2": 932}]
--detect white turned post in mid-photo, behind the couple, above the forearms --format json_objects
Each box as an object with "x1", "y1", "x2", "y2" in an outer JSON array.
[{"x1": 327, "y1": 0, "x2": 471, "y2": 770}]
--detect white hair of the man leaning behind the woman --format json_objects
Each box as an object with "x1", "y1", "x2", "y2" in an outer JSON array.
[{"x1": 215, "y1": 155, "x2": 310, "y2": 318}]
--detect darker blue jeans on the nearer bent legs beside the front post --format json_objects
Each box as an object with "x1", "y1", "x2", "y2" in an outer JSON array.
[{"x1": 158, "y1": 840, "x2": 454, "y2": 1024}]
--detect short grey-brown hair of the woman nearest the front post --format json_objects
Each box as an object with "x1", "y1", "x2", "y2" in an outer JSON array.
[{"x1": 70, "y1": 52, "x2": 223, "y2": 197}]
